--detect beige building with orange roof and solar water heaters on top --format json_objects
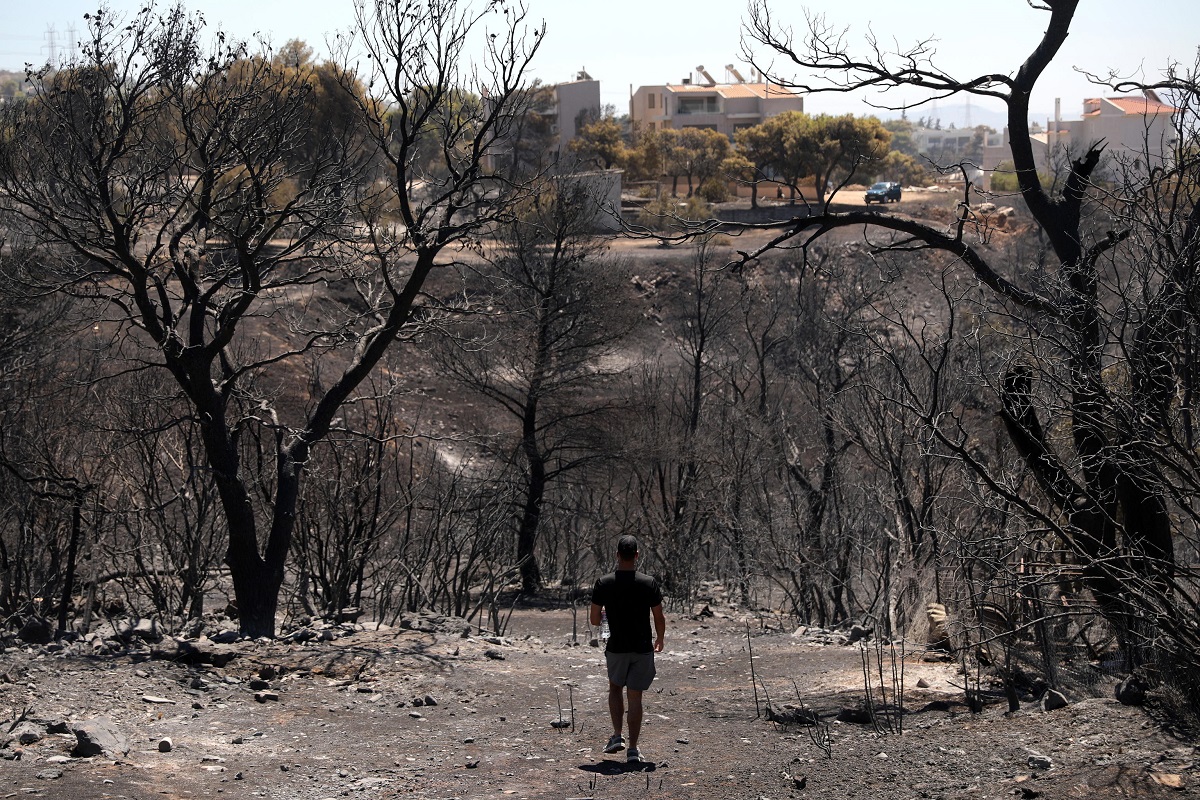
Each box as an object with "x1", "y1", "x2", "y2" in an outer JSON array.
[{"x1": 629, "y1": 67, "x2": 804, "y2": 137}]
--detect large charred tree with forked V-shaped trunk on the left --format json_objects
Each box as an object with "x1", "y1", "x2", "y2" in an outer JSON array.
[{"x1": 0, "y1": 0, "x2": 541, "y2": 636}]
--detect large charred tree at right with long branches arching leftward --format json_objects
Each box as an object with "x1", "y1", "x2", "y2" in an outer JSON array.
[{"x1": 748, "y1": 0, "x2": 1200, "y2": 690}]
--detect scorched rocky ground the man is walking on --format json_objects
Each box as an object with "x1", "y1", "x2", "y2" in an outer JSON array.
[{"x1": 0, "y1": 609, "x2": 1200, "y2": 800}]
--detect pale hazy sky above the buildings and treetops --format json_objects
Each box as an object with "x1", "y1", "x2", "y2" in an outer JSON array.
[{"x1": 0, "y1": 0, "x2": 1200, "y2": 119}]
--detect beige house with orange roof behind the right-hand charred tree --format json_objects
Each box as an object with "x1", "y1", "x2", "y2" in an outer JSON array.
[{"x1": 983, "y1": 91, "x2": 1177, "y2": 185}]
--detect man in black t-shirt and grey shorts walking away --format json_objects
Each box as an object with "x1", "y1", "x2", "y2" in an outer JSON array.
[{"x1": 590, "y1": 535, "x2": 667, "y2": 764}]
